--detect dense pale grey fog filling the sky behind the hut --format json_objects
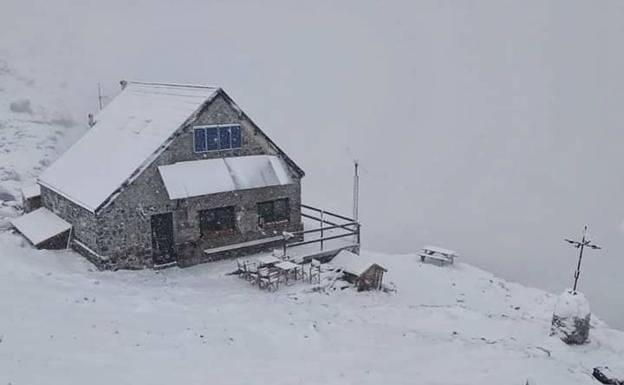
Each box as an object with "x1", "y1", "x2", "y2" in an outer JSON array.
[{"x1": 0, "y1": 0, "x2": 624, "y2": 328}]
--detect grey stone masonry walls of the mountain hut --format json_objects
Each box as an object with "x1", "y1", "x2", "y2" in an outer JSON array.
[{"x1": 41, "y1": 91, "x2": 302, "y2": 269}]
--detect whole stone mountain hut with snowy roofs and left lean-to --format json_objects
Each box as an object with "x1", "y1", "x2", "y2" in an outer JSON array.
[{"x1": 13, "y1": 81, "x2": 304, "y2": 269}]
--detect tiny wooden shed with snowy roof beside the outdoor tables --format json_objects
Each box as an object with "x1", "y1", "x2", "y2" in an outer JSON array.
[{"x1": 331, "y1": 250, "x2": 388, "y2": 291}]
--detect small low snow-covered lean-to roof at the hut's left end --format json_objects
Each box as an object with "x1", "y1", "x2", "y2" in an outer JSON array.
[{"x1": 11, "y1": 207, "x2": 72, "y2": 246}]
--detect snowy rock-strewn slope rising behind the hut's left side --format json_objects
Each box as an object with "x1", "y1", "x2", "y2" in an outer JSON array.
[{"x1": 0, "y1": 57, "x2": 83, "y2": 229}]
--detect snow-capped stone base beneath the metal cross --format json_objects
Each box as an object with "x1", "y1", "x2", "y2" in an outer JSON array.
[{"x1": 551, "y1": 289, "x2": 591, "y2": 344}]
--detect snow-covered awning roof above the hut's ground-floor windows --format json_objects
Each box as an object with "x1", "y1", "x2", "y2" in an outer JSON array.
[{"x1": 158, "y1": 155, "x2": 292, "y2": 199}]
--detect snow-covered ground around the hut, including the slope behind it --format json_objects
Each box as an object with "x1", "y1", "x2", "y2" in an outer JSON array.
[{"x1": 0, "y1": 57, "x2": 624, "y2": 385}]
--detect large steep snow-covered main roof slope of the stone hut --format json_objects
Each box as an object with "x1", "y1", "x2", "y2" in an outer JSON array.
[{"x1": 39, "y1": 82, "x2": 219, "y2": 212}]
